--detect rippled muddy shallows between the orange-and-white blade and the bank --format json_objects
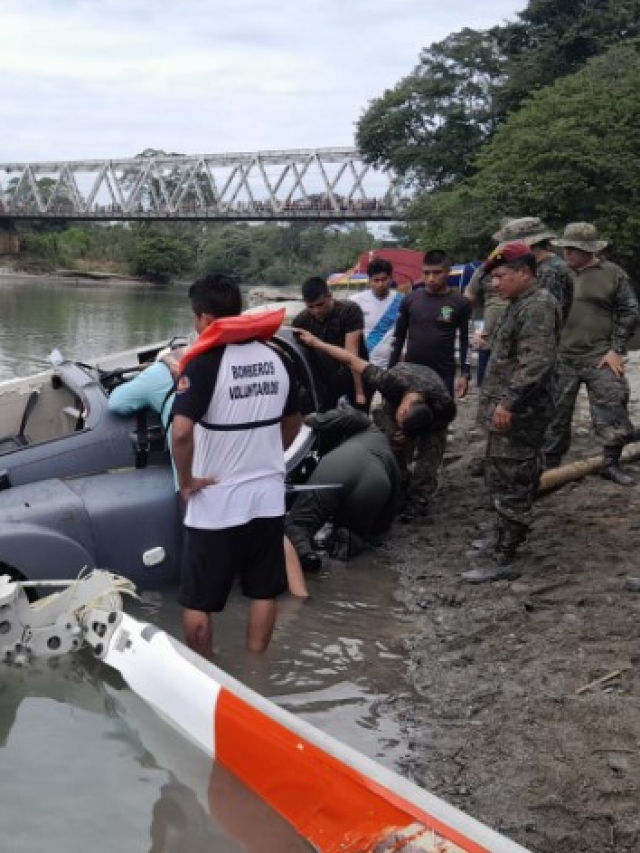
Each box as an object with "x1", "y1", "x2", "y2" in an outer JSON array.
[{"x1": 132, "y1": 554, "x2": 416, "y2": 768}]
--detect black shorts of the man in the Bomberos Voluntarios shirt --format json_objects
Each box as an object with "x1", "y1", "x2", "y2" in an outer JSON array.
[{"x1": 178, "y1": 516, "x2": 287, "y2": 613}]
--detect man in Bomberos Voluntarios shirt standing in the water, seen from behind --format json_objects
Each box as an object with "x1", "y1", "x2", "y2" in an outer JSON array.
[{"x1": 172, "y1": 275, "x2": 301, "y2": 657}]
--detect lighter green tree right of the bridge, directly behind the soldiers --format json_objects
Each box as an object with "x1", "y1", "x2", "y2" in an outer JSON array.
[{"x1": 411, "y1": 43, "x2": 640, "y2": 273}]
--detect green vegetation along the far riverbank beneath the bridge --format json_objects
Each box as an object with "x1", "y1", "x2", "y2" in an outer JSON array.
[{"x1": 15, "y1": 222, "x2": 381, "y2": 286}]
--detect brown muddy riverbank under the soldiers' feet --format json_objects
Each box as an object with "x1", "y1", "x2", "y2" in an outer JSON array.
[{"x1": 388, "y1": 362, "x2": 640, "y2": 853}]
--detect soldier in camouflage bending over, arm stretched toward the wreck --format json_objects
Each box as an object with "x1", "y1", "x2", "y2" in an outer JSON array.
[{"x1": 290, "y1": 330, "x2": 456, "y2": 521}]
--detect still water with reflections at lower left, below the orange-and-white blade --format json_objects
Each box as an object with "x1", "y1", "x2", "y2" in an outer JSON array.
[{"x1": 0, "y1": 655, "x2": 310, "y2": 853}]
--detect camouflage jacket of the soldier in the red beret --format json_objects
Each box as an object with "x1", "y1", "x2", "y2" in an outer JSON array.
[{"x1": 478, "y1": 284, "x2": 561, "y2": 445}]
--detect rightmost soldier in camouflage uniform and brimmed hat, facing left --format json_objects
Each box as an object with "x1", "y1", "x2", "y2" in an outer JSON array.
[{"x1": 545, "y1": 222, "x2": 638, "y2": 486}]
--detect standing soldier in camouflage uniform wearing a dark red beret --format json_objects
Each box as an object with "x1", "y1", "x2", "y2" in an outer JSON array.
[{"x1": 463, "y1": 242, "x2": 561, "y2": 583}]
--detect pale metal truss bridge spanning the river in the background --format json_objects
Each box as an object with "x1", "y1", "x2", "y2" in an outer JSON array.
[{"x1": 0, "y1": 148, "x2": 406, "y2": 222}]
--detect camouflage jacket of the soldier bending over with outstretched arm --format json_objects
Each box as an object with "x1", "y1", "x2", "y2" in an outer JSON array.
[{"x1": 363, "y1": 361, "x2": 456, "y2": 429}]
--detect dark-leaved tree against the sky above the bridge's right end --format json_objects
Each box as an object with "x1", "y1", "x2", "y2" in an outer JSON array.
[{"x1": 356, "y1": 28, "x2": 505, "y2": 189}]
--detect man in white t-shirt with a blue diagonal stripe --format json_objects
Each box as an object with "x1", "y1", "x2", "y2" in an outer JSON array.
[{"x1": 349, "y1": 258, "x2": 403, "y2": 370}]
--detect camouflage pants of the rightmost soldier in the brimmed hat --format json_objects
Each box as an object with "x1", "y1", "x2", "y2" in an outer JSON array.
[{"x1": 544, "y1": 360, "x2": 633, "y2": 459}]
